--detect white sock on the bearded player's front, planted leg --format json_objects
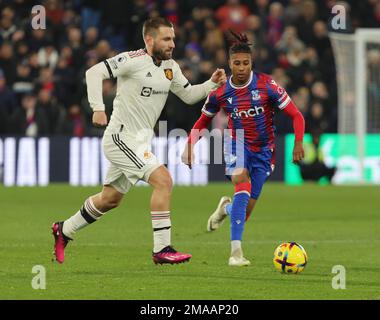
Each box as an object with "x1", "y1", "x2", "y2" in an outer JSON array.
[{"x1": 150, "y1": 211, "x2": 172, "y2": 252}]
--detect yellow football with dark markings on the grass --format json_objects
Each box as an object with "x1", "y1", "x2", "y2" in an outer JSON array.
[{"x1": 273, "y1": 242, "x2": 307, "y2": 274}]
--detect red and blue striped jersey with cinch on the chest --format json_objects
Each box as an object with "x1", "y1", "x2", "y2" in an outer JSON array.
[{"x1": 202, "y1": 71, "x2": 291, "y2": 152}]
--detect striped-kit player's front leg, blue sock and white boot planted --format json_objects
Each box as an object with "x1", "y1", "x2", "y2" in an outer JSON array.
[{"x1": 228, "y1": 169, "x2": 251, "y2": 267}]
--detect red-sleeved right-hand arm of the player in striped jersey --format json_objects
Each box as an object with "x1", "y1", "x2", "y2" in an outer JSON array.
[{"x1": 283, "y1": 101, "x2": 305, "y2": 163}]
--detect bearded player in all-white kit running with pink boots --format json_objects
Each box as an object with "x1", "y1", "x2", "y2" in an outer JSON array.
[{"x1": 52, "y1": 17, "x2": 226, "y2": 264}]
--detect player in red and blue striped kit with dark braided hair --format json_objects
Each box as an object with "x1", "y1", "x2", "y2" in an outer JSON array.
[{"x1": 182, "y1": 32, "x2": 305, "y2": 266}]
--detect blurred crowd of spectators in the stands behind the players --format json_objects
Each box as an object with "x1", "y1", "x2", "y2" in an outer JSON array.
[{"x1": 0, "y1": 0, "x2": 380, "y2": 137}]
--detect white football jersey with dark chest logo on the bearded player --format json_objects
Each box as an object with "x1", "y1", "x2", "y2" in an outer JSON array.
[{"x1": 104, "y1": 49, "x2": 215, "y2": 136}]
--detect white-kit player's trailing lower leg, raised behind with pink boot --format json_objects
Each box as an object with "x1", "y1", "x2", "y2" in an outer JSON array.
[{"x1": 52, "y1": 186, "x2": 123, "y2": 263}]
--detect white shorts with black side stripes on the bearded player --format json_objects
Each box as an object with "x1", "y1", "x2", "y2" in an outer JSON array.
[{"x1": 102, "y1": 132, "x2": 161, "y2": 194}]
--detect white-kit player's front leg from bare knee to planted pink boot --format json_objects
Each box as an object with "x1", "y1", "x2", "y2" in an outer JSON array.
[{"x1": 148, "y1": 166, "x2": 191, "y2": 264}]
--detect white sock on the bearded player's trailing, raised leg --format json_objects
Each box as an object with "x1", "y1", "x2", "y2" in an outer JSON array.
[{"x1": 62, "y1": 197, "x2": 103, "y2": 239}]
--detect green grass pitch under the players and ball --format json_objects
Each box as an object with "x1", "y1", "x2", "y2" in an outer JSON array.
[{"x1": 0, "y1": 182, "x2": 380, "y2": 300}]
